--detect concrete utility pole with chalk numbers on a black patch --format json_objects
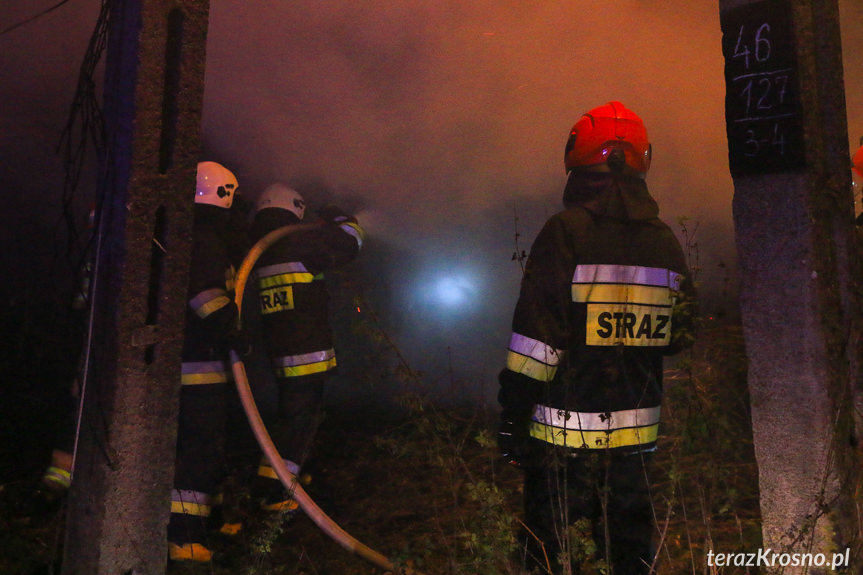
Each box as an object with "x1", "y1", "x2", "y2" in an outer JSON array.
[{"x1": 716, "y1": 0, "x2": 863, "y2": 573}]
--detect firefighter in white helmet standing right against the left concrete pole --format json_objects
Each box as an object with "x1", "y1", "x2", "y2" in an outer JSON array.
[{"x1": 168, "y1": 162, "x2": 249, "y2": 562}]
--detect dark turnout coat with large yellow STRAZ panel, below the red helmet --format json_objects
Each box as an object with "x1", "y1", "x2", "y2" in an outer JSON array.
[{"x1": 499, "y1": 172, "x2": 694, "y2": 452}]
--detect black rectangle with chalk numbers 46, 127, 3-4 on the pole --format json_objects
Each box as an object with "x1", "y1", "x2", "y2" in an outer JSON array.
[{"x1": 721, "y1": 0, "x2": 806, "y2": 176}]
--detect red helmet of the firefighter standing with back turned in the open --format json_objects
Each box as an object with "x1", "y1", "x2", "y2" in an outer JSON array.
[{"x1": 564, "y1": 102, "x2": 650, "y2": 176}]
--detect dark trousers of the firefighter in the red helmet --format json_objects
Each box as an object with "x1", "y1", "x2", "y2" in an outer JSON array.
[{"x1": 524, "y1": 451, "x2": 654, "y2": 575}]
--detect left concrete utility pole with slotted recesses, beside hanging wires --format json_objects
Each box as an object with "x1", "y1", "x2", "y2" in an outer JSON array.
[{"x1": 62, "y1": 0, "x2": 209, "y2": 575}]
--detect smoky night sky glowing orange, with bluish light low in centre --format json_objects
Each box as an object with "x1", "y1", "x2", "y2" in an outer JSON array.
[{"x1": 0, "y1": 0, "x2": 863, "y2": 404}]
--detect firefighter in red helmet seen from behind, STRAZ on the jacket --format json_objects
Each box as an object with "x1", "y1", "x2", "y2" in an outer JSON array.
[{"x1": 498, "y1": 102, "x2": 694, "y2": 575}]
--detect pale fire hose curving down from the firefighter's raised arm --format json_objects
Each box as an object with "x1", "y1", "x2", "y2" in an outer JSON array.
[{"x1": 230, "y1": 224, "x2": 422, "y2": 575}]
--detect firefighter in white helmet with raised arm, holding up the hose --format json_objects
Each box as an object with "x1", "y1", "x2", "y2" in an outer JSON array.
[{"x1": 251, "y1": 183, "x2": 363, "y2": 512}]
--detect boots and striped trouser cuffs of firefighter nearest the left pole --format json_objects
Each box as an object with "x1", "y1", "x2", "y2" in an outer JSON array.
[{"x1": 168, "y1": 489, "x2": 213, "y2": 563}]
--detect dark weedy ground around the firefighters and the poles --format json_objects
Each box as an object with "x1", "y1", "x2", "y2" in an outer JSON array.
[{"x1": 0, "y1": 327, "x2": 760, "y2": 575}]
